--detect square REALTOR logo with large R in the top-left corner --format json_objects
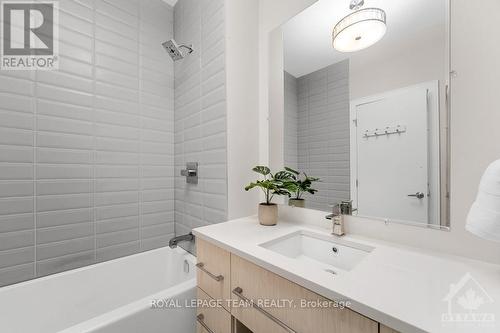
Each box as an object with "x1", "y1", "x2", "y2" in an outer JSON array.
[{"x1": 1, "y1": 1, "x2": 59, "y2": 70}]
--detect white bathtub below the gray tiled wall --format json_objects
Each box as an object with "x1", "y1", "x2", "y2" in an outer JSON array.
[{"x1": 0, "y1": 247, "x2": 196, "y2": 333}]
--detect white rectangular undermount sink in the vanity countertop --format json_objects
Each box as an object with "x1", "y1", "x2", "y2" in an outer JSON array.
[{"x1": 260, "y1": 230, "x2": 374, "y2": 274}]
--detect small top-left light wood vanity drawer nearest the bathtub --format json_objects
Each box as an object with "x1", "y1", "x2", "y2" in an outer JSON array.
[{"x1": 196, "y1": 238, "x2": 231, "y2": 308}]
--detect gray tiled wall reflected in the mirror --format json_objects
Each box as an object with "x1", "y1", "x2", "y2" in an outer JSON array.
[{"x1": 285, "y1": 60, "x2": 350, "y2": 211}]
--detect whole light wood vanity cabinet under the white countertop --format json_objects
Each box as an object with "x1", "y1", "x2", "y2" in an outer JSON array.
[{"x1": 197, "y1": 238, "x2": 397, "y2": 333}]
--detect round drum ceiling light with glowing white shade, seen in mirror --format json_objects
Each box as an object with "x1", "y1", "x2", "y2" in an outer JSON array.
[{"x1": 333, "y1": 0, "x2": 387, "y2": 52}]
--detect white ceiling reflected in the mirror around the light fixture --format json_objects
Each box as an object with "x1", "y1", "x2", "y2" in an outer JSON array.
[{"x1": 282, "y1": 0, "x2": 448, "y2": 77}]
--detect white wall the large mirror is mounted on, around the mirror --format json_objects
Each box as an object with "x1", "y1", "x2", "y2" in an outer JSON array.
[{"x1": 260, "y1": 0, "x2": 500, "y2": 263}]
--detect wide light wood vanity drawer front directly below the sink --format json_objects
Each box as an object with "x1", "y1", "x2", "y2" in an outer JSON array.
[{"x1": 231, "y1": 255, "x2": 378, "y2": 333}]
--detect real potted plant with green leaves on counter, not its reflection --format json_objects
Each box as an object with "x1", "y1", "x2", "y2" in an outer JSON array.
[{"x1": 245, "y1": 166, "x2": 292, "y2": 226}]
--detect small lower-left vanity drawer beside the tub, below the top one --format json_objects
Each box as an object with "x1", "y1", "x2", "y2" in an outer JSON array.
[{"x1": 196, "y1": 288, "x2": 231, "y2": 333}]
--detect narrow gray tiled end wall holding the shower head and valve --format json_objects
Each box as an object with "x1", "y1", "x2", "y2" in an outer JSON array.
[{"x1": 174, "y1": 0, "x2": 227, "y2": 239}]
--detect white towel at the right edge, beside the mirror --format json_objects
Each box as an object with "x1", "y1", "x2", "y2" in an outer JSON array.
[{"x1": 465, "y1": 160, "x2": 500, "y2": 242}]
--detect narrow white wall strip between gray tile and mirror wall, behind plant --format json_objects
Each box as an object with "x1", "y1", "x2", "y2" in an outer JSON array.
[{"x1": 226, "y1": 0, "x2": 259, "y2": 219}]
